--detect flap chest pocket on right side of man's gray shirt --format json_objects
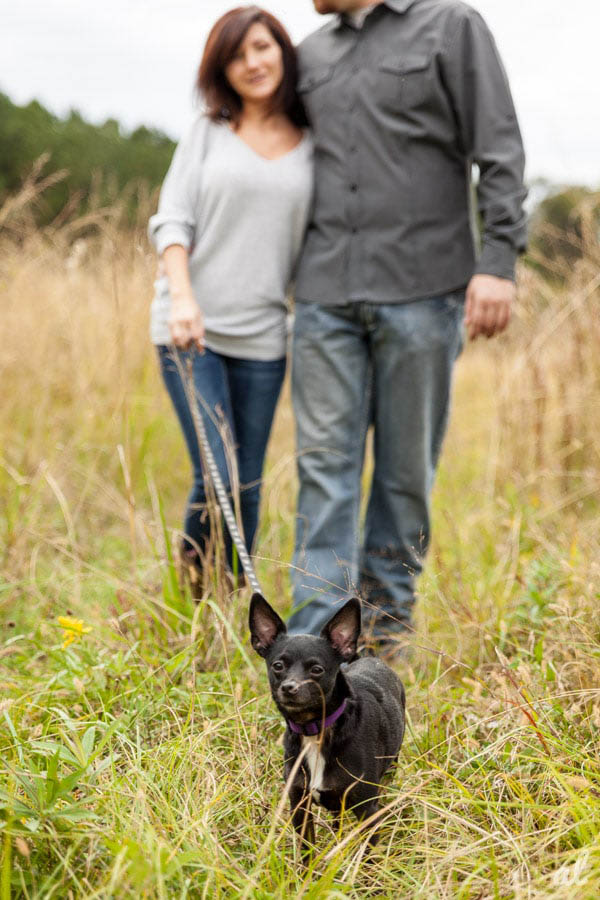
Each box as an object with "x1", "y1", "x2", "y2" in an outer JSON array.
[{"x1": 375, "y1": 56, "x2": 433, "y2": 112}]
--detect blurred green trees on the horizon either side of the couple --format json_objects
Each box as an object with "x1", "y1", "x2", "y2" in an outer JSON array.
[{"x1": 0, "y1": 93, "x2": 600, "y2": 277}]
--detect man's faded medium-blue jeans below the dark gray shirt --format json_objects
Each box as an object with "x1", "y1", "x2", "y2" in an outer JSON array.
[{"x1": 289, "y1": 291, "x2": 464, "y2": 637}]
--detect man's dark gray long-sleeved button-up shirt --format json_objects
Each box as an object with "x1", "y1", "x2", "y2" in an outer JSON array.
[{"x1": 296, "y1": 0, "x2": 525, "y2": 304}]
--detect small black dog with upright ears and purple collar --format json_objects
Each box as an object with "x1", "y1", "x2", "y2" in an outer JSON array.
[{"x1": 250, "y1": 594, "x2": 405, "y2": 844}]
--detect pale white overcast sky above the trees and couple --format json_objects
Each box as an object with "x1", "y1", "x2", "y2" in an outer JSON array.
[{"x1": 0, "y1": 0, "x2": 600, "y2": 187}]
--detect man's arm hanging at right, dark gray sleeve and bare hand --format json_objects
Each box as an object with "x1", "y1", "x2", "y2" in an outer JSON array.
[{"x1": 441, "y1": 7, "x2": 526, "y2": 338}]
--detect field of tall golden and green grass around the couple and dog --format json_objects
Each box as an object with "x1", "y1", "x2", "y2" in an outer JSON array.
[{"x1": 0, "y1": 185, "x2": 600, "y2": 900}]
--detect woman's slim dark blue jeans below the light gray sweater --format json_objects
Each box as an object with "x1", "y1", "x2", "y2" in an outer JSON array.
[{"x1": 157, "y1": 345, "x2": 286, "y2": 566}]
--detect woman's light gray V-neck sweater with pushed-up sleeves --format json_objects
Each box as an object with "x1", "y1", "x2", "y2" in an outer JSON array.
[{"x1": 149, "y1": 115, "x2": 313, "y2": 360}]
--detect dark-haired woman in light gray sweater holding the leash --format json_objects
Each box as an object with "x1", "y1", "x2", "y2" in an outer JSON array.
[{"x1": 150, "y1": 6, "x2": 312, "y2": 581}]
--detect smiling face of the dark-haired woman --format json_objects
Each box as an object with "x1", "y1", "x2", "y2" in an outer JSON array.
[{"x1": 225, "y1": 22, "x2": 283, "y2": 103}]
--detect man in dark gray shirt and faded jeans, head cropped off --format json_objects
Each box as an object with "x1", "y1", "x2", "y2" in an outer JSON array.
[{"x1": 290, "y1": 0, "x2": 525, "y2": 649}]
